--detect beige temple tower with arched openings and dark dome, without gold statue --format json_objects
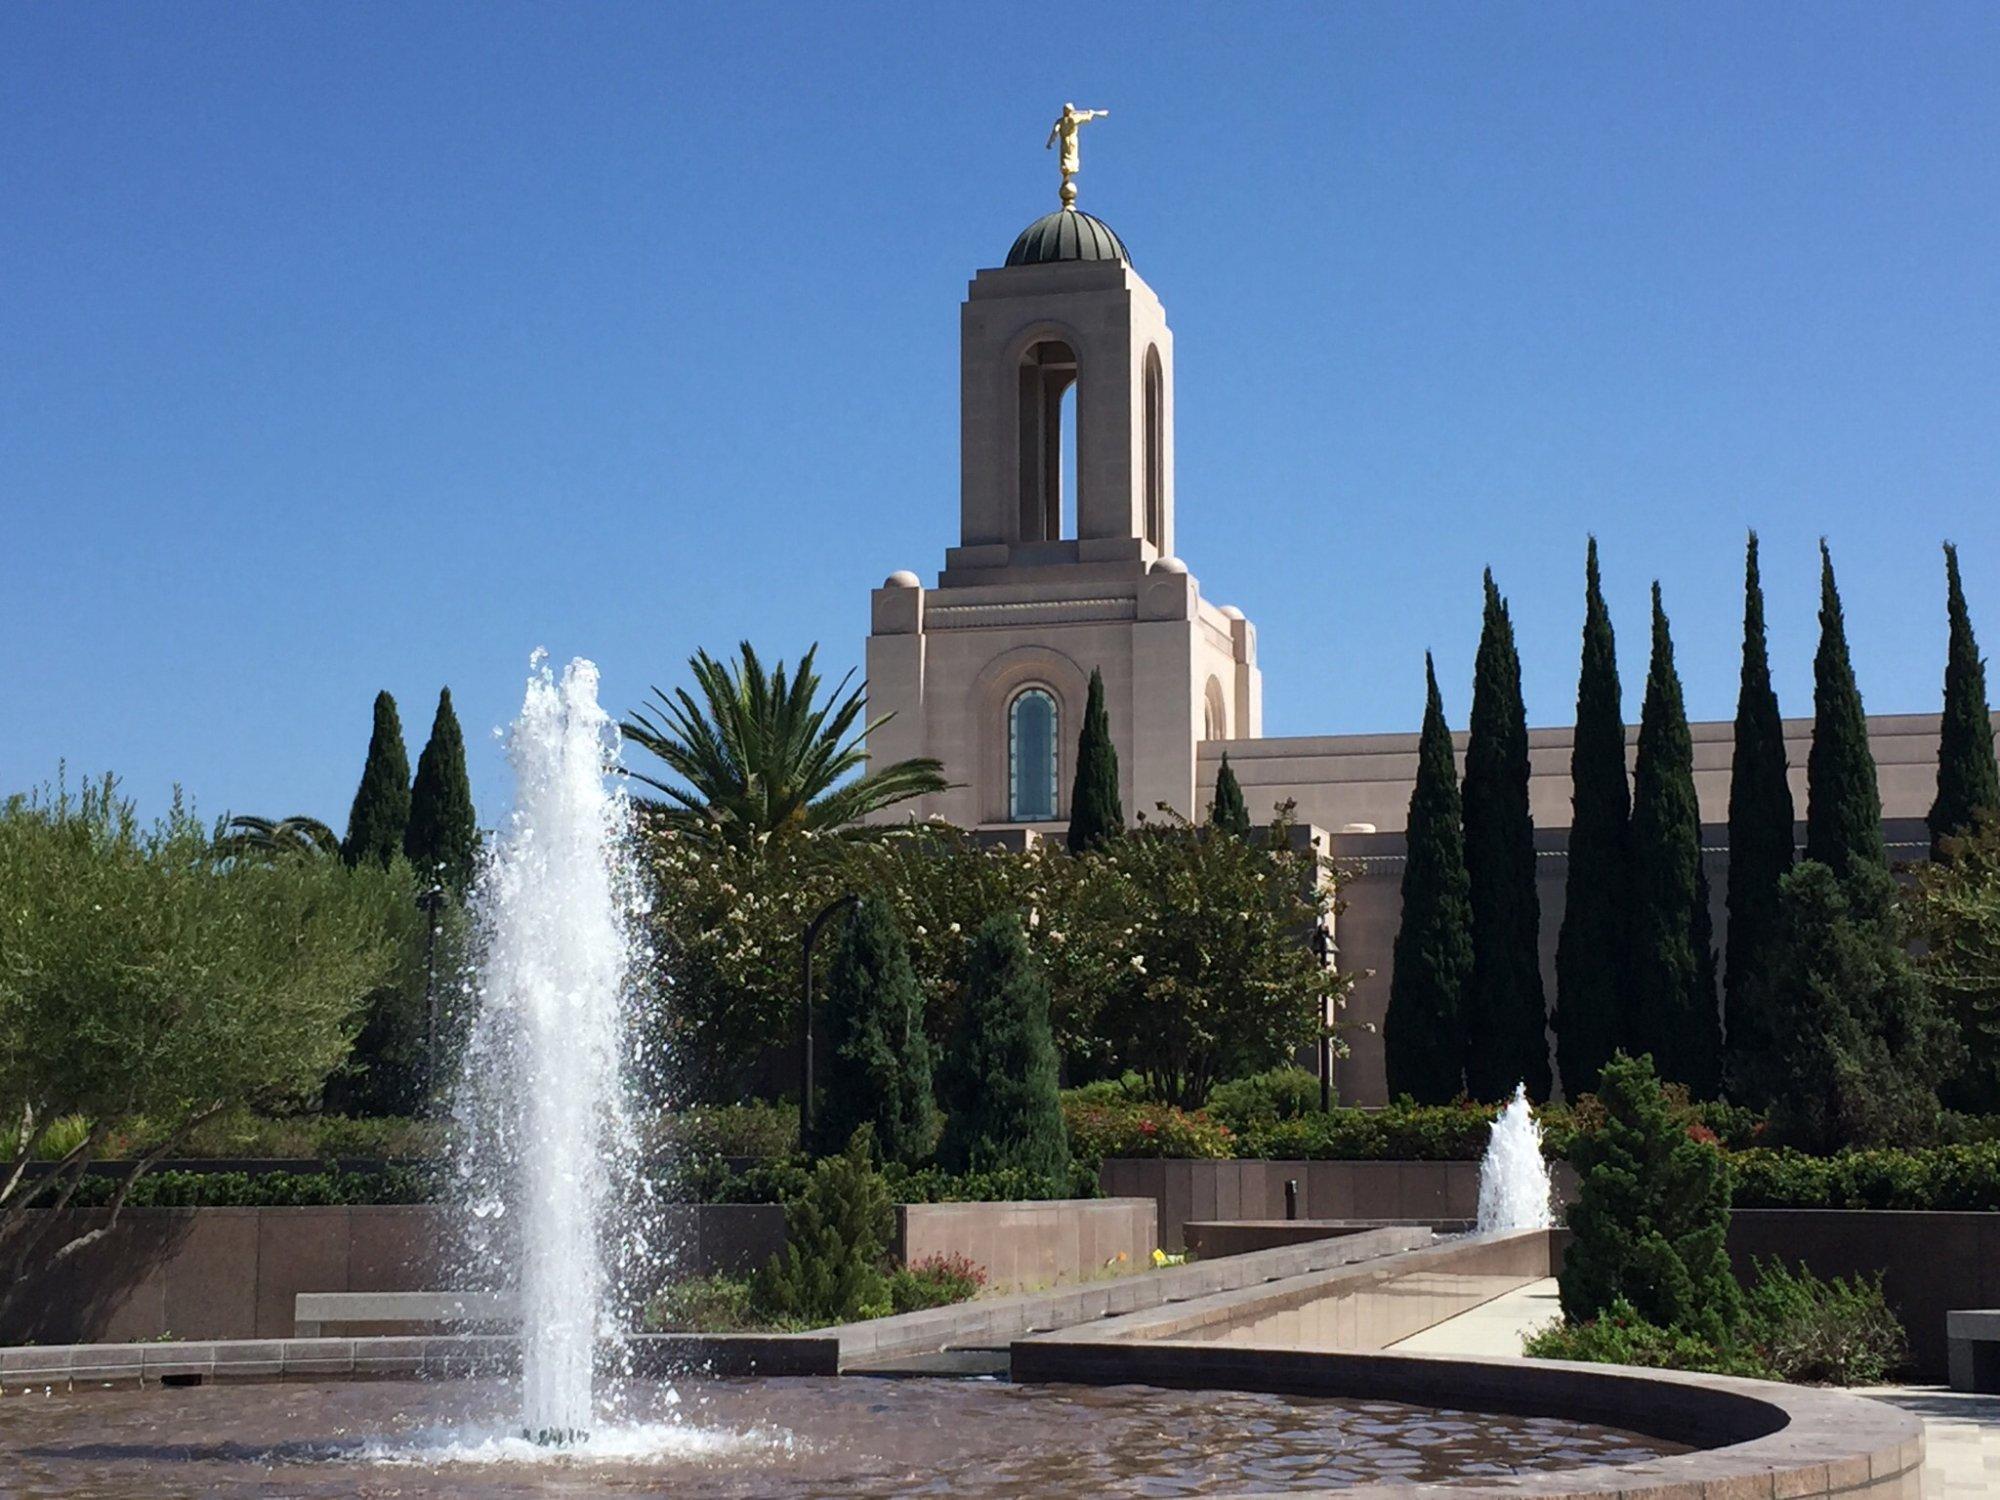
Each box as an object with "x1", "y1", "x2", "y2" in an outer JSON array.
[{"x1": 868, "y1": 197, "x2": 1262, "y2": 832}]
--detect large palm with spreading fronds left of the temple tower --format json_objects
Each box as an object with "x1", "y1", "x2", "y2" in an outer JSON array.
[{"x1": 620, "y1": 640, "x2": 946, "y2": 848}]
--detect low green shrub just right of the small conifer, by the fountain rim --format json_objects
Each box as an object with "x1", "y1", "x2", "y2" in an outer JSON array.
[{"x1": 1744, "y1": 1260, "x2": 1910, "y2": 1386}]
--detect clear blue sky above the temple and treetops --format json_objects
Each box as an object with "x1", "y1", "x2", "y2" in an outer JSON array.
[{"x1": 0, "y1": 2, "x2": 2000, "y2": 826}]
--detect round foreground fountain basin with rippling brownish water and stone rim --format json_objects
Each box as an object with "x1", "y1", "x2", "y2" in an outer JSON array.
[{"x1": 0, "y1": 1328, "x2": 1922, "y2": 1500}]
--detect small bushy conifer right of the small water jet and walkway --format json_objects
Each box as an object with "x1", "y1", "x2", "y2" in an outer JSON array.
[{"x1": 1562, "y1": 1054, "x2": 1742, "y2": 1342}]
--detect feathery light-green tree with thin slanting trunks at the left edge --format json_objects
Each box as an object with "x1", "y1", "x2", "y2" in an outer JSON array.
[{"x1": 0, "y1": 778, "x2": 416, "y2": 1286}]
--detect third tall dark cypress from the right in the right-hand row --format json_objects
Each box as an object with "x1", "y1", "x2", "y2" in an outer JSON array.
[{"x1": 1724, "y1": 532, "x2": 1794, "y2": 1078}]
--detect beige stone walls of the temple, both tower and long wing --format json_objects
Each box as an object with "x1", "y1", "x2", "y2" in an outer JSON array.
[{"x1": 868, "y1": 209, "x2": 1992, "y2": 1104}]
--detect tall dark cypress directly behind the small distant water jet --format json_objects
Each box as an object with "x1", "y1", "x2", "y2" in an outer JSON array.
[{"x1": 1464, "y1": 568, "x2": 1550, "y2": 1100}]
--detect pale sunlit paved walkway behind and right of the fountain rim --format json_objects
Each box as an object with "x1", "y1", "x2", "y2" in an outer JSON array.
[{"x1": 1394, "y1": 1278, "x2": 2000, "y2": 1500}]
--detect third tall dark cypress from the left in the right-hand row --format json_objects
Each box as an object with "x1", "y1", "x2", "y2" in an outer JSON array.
[{"x1": 1556, "y1": 536, "x2": 1632, "y2": 1098}]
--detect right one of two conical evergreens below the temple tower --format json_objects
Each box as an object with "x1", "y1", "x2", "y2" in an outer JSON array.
[{"x1": 938, "y1": 912, "x2": 1070, "y2": 1176}]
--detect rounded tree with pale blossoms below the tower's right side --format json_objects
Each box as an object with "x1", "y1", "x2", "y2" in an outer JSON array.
[{"x1": 1080, "y1": 810, "x2": 1346, "y2": 1108}]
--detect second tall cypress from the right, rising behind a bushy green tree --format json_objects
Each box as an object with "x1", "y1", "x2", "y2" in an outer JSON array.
[{"x1": 1806, "y1": 540, "x2": 1888, "y2": 880}]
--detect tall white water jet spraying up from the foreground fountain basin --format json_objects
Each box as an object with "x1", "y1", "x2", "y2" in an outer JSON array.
[{"x1": 456, "y1": 652, "x2": 638, "y2": 1444}]
